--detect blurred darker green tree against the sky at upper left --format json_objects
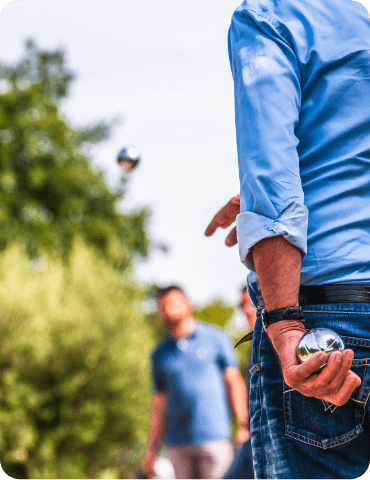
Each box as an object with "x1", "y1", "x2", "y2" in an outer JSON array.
[{"x1": 0, "y1": 40, "x2": 158, "y2": 270}]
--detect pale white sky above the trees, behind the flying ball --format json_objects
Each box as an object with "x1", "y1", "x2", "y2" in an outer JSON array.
[{"x1": 0, "y1": 0, "x2": 248, "y2": 304}]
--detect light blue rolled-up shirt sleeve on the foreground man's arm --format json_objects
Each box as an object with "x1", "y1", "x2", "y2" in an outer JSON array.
[{"x1": 229, "y1": 4, "x2": 308, "y2": 271}]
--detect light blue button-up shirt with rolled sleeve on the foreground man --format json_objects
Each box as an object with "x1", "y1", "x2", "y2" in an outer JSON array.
[{"x1": 229, "y1": 0, "x2": 370, "y2": 285}]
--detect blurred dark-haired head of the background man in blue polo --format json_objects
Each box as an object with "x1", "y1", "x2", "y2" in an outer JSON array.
[{"x1": 156, "y1": 285, "x2": 194, "y2": 327}]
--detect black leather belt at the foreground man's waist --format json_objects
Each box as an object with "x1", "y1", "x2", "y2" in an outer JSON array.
[{"x1": 299, "y1": 283, "x2": 370, "y2": 305}]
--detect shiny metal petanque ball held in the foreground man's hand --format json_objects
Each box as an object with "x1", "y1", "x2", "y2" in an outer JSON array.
[{"x1": 297, "y1": 328, "x2": 344, "y2": 373}]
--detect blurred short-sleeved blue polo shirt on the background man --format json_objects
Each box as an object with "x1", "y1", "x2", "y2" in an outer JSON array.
[{"x1": 152, "y1": 322, "x2": 237, "y2": 446}]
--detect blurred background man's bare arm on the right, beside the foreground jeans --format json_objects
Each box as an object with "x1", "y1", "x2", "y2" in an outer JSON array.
[{"x1": 224, "y1": 367, "x2": 250, "y2": 444}]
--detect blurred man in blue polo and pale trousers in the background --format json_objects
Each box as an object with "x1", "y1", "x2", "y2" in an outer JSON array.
[{"x1": 142, "y1": 285, "x2": 249, "y2": 479}]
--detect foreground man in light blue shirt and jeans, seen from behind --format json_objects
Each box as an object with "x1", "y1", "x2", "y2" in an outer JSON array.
[{"x1": 206, "y1": 0, "x2": 370, "y2": 479}]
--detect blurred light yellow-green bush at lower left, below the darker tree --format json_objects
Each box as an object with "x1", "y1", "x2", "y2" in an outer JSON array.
[{"x1": 0, "y1": 240, "x2": 155, "y2": 479}]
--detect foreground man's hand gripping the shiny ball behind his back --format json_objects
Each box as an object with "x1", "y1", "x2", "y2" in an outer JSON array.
[{"x1": 268, "y1": 320, "x2": 361, "y2": 406}]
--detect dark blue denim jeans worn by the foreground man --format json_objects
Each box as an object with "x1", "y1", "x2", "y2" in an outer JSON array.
[{"x1": 249, "y1": 303, "x2": 370, "y2": 480}]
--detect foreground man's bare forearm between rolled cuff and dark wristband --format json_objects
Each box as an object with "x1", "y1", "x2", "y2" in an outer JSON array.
[{"x1": 252, "y1": 235, "x2": 302, "y2": 311}]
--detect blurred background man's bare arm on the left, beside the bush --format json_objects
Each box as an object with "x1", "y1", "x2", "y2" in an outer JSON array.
[{"x1": 142, "y1": 392, "x2": 167, "y2": 478}]
